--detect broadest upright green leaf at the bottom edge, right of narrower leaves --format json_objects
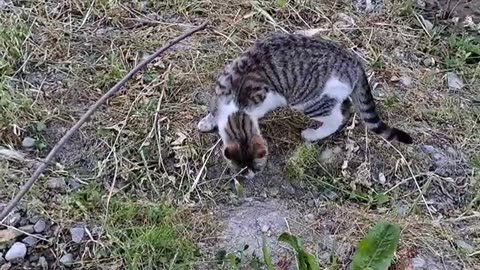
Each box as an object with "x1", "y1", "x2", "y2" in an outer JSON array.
[{"x1": 352, "y1": 222, "x2": 400, "y2": 270}]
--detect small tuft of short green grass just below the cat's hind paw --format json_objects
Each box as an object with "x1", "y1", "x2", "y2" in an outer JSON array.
[{"x1": 287, "y1": 144, "x2": 320, "y2": 181}]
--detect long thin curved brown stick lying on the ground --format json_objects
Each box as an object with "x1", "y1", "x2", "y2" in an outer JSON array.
[{"x1": 0, "y1": 22, "x2": 208, "y2": 223}]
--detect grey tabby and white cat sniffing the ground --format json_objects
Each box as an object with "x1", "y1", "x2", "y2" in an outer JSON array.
[{"x1": 197, "y1": 34, "x2": 413, "y2": 177}]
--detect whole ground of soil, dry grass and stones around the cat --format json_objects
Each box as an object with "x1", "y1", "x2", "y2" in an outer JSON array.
[{"x1": 0, "y1": 0, "x2": 480, "y2": 270}]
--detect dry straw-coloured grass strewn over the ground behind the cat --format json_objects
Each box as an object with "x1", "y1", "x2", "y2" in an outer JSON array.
[{"x1": 0, "y1": 0, "x2": 480, "y2": 268}]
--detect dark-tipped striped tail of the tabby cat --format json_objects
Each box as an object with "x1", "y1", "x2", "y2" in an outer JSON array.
[{"x1": 351, "y1": 70, "x2": 413, "y2": 144}]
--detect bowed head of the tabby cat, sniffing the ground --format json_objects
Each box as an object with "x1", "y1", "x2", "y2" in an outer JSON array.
[{"x1": 220, "y1": 111, "x2": 268, "y2": 178}]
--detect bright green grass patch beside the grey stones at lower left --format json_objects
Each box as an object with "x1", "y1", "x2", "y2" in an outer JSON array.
[{"x1": 107, "y1": 197, "x2": 197, "y2": 269}]
